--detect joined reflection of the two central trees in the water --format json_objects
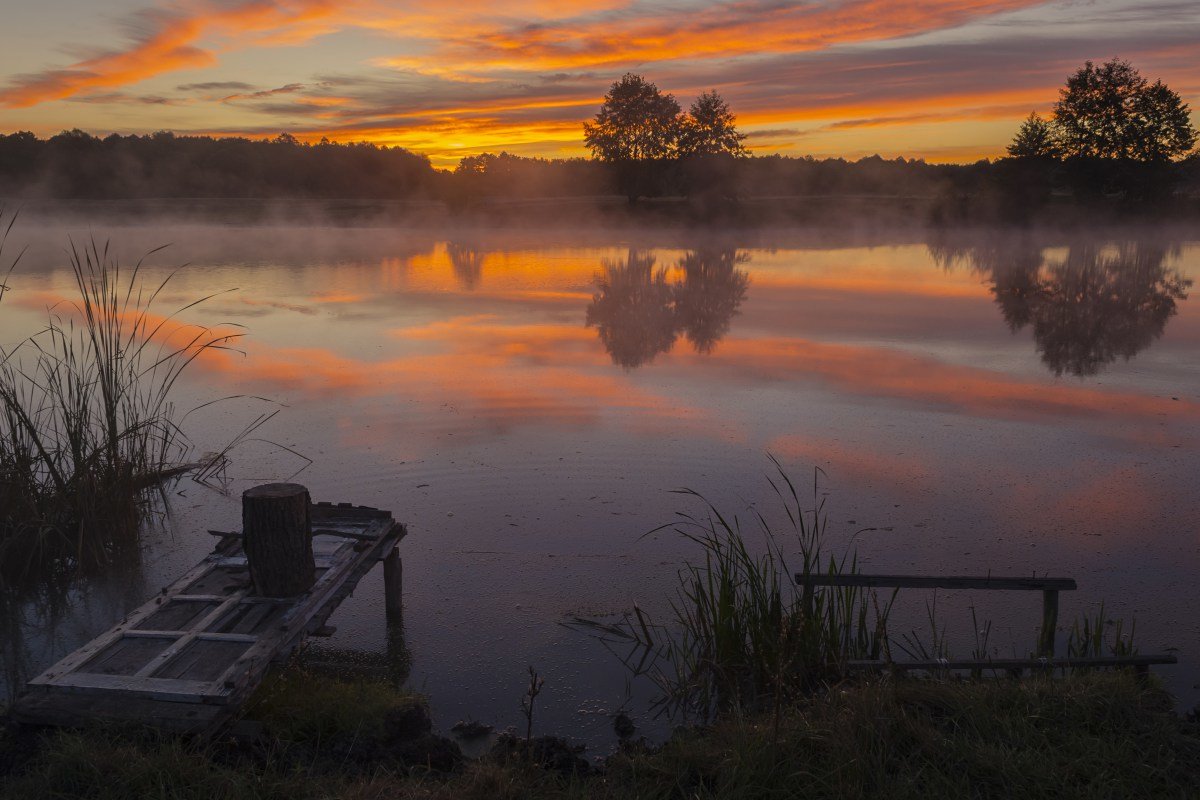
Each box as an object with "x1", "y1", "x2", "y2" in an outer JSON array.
[{"x1": 587, "y1": 248, "x2": 750, "y2": 369}]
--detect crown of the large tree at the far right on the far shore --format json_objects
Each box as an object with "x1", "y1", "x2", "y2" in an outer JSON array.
[{"x1": 1054, "y1": 59, "x2": 1196, "y2": 162}]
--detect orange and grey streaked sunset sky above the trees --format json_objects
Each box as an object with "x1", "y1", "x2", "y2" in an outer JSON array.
[{"x1": 0, "y1": 0, "x2": 1200, "y2": 167}]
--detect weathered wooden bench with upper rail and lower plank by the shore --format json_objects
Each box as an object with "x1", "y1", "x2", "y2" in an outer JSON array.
[{"x1": 796, "y1": 572, "x2": 1178, "y2": 675}]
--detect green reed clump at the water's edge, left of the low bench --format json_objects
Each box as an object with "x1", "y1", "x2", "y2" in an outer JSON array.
[{"x1": 575, "y1": 457, "x2": 894, "y2": 717}]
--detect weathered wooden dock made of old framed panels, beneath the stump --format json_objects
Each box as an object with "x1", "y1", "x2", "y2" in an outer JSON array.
[{"x1": 12, "y1": 487, "x2": 407, "y2": 734}]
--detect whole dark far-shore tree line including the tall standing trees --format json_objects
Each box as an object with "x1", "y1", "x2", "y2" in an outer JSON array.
[{"x1": 0, "y1": 60, "x2": 1200, "y2": 215}]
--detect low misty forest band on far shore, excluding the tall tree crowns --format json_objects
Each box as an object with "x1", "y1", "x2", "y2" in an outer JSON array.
[{"x1": 0, "y1": 131, "x2": 1200, "y2": 209}]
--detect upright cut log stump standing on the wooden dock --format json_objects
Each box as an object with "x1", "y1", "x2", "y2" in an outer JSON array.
[{"x1": 241, "y1": 483, "x2": 316, "y2": 597}]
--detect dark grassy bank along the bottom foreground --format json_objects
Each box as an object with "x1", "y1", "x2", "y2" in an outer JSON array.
[{"x1": 0, "y1": 673, "x2": 1200, "y2": 800}]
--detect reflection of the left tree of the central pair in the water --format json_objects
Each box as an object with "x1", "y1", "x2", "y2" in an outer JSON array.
[{"x1": 587, "y1": 249, "x2": 678, "y2": 369}]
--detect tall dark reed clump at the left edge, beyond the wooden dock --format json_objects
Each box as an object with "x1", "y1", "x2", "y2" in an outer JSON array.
[{"x1": 0, "y1": 222, "x2": 238, "y2": 582}]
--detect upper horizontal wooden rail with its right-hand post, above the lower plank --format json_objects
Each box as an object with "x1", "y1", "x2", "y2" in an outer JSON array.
[{"x1": 796, "y1": 572, "x2": 1076, "y2": 658}]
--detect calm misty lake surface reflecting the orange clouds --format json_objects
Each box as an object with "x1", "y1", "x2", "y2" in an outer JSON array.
[{"x1": 0, "y1": 213, "x2": 1200, "y2": 748}]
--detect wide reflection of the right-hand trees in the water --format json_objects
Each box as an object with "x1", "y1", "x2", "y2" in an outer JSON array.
[{"x1": 930, "y1": 237, "x2": 1192, "y2": 377}]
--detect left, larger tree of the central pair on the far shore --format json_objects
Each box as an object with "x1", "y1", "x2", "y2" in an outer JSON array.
[{"x1": 583, "y1": 73, "x2": 679, "y2": 203}]
